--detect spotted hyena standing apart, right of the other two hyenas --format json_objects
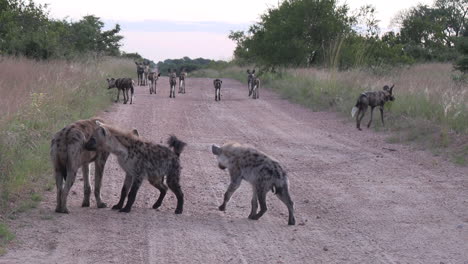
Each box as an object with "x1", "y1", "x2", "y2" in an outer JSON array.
[{"x1": 212, "y1": 143, "x2": 296, "y2": 225}]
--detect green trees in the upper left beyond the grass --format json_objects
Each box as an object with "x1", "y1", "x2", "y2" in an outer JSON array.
[{"x1": 0, "y1": 0, "x2": 123, "y2": 59}]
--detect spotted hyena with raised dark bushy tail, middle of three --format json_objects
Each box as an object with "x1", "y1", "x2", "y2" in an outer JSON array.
[{"x1": 86, "y1": 122, "x2": 186, "y2": 214}]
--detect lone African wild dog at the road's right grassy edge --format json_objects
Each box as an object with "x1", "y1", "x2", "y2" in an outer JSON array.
[{"x1": 351, "y1": 85, "x2": 395, "y2": 130}]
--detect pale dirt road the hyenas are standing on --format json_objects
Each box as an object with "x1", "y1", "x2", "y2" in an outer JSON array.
[{"x1": 0, "y1": 78, "x2": 468, "y2": 263}]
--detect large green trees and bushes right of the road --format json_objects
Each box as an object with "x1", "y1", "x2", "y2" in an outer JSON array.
[{"x1": 229, "y1": 0, "x2": 468, "y2": 70}]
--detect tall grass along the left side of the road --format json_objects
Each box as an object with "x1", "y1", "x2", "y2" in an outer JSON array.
[{"x1": 0, "y1": 57, "x2": 136, "y2": 221}]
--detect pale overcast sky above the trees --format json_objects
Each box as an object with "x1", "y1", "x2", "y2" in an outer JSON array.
[{"x1": 34, "y1": 0, "x2": 434, "y2": 62}]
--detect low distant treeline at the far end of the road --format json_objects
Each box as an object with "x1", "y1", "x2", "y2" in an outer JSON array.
[{"x1": 156, "y1": 57, "x2": 228, "y2": 75}]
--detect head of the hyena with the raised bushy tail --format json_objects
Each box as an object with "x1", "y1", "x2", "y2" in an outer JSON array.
[{"x1": 85, "y1": 121, "x2": 139, "y2": 152}]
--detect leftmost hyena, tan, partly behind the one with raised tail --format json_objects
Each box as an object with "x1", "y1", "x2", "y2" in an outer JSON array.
[{"x1": 50, "y1": 118, "x2": 109, "y2": 213}]
